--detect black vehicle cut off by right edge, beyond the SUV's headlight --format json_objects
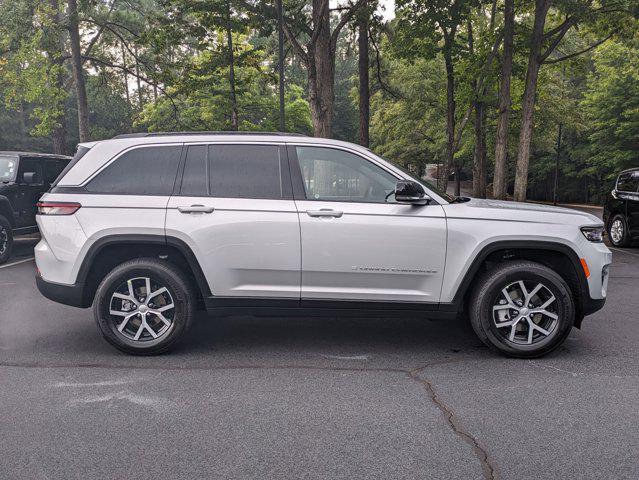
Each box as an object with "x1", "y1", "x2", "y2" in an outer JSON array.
[{"x1": 604, "y1": 167, "x2": 639, "y2": 247}]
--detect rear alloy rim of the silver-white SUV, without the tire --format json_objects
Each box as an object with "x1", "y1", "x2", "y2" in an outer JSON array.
[{"x1": 109, "y1": 277, "x2": 175, "y2": 342}]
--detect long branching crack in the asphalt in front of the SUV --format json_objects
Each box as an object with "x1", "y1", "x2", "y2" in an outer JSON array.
[{"x1": 0, "y1": 358, "x2": 498, "y2": 480}]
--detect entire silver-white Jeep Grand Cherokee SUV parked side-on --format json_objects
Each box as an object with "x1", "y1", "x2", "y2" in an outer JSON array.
[{"x1": 36, "y1": 133, "x2": 612, "y2": 357}]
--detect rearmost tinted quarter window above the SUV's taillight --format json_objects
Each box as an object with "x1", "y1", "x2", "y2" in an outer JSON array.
[{"x1": 87, "y1": 146, "x2": 182, "y2": 195}]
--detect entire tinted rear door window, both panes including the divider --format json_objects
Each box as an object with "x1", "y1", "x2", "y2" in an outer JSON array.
[{"x1": 180, "y1": 144, "x2": 290, "y2": 199}]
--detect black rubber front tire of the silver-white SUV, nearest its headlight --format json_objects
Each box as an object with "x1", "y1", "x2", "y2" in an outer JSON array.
[{"x1": 468, "y1": 261, "x2": 575, "y2": 358}]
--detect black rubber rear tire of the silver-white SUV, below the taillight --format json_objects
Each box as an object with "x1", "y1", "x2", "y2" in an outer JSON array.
[{"x1": 93, "y1": 258, "x2": 197, "y2": 355}]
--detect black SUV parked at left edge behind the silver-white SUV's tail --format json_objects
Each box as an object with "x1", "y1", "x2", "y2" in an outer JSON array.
[{"x1": 0, "y1": 152, "x2": 71, "y2": 264}]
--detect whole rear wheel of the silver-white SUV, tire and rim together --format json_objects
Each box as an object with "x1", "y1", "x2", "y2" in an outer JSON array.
[{"x1": 93, "y1": 258, "x2": 196, "y2": 355}]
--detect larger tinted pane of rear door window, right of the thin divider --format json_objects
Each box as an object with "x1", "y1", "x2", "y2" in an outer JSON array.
[{"x1": 208, "y1": 145, "x2": 282, "y2": 199}]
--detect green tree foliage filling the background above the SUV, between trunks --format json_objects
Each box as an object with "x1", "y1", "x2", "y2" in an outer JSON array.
[{"x1": 0, "y1": 0, "x2": 639, "y2": 201}]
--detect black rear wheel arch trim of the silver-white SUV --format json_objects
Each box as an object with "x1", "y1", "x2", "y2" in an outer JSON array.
[{"x1": 76, "y1": 234, "x2": 211, "y2": 307}]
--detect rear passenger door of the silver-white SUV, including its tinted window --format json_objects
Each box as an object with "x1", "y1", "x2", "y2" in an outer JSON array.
[{"x1": 166, "y1": 144, "x2": 301, "y2": 299}]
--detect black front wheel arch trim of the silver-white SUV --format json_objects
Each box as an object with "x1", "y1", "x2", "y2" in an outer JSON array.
[{"x1": 452, "y1": 240, "x2": 590, "y2": 327}]
